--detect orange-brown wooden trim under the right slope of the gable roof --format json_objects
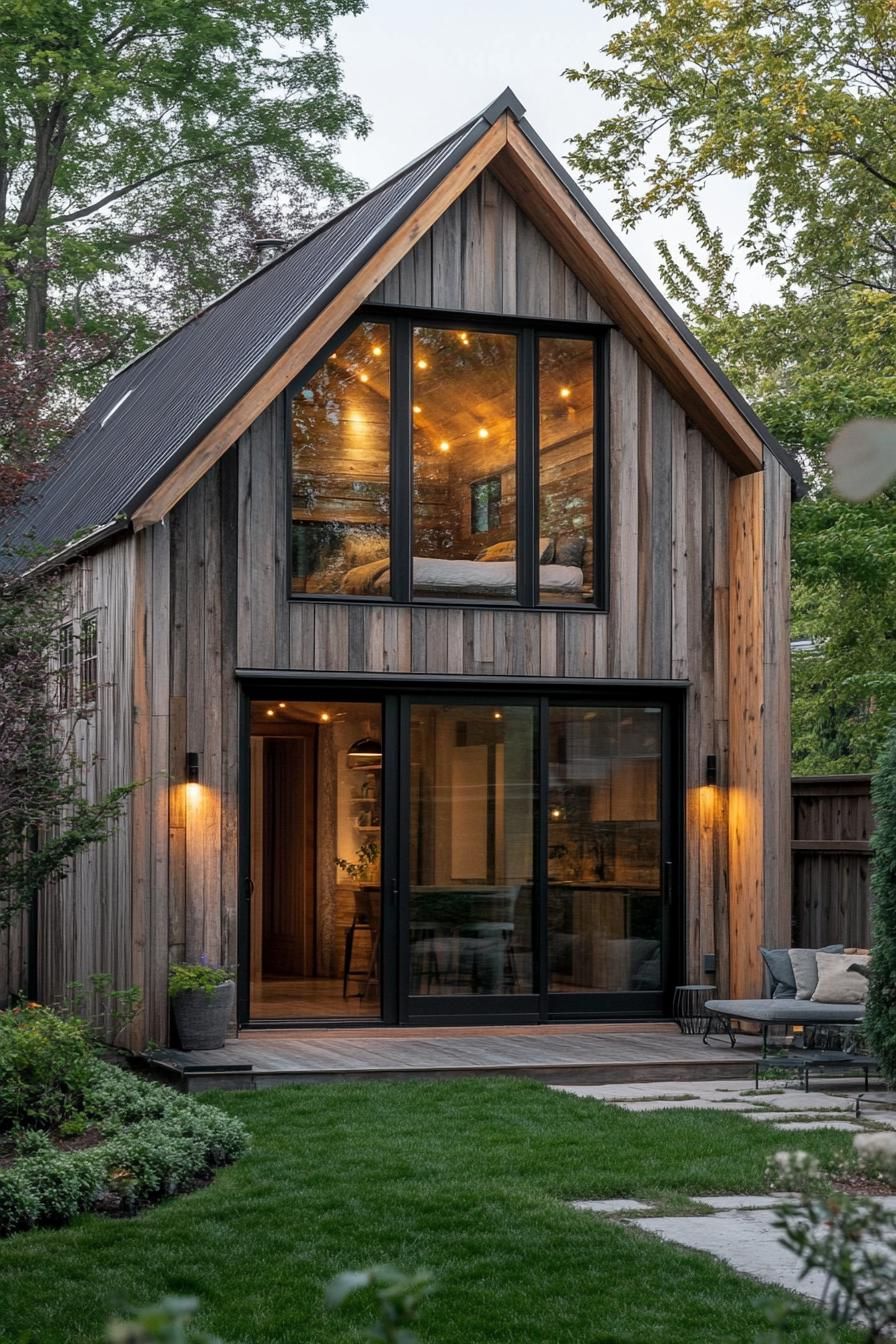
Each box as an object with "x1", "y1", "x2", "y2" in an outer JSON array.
[{"x1": 492, "y1": 122, "x2": 763, "y2": 472}]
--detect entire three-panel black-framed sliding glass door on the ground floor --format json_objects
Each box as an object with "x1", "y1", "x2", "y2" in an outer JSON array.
[{"x1": 240, "y1": 691, "x2": 681, "y2": 1024}]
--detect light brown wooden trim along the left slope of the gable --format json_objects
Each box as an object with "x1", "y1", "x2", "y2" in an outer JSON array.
[{"x1": 132, "y1": 113, "x2": 510, "y2": 531}]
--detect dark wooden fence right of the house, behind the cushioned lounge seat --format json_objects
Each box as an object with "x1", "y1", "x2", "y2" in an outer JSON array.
[{"x1": 793, "y1": 774, "x2": 873, "y2": 948}]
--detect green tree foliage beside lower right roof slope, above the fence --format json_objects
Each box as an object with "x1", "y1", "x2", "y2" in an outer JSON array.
[{"x1": 664, "y1": 270, "x2": 896, "y2": 774}]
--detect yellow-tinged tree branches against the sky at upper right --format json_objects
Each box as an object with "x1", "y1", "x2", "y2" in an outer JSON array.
[{"x1": 567, "y1": 0, "x2": 896, "y2": 293}]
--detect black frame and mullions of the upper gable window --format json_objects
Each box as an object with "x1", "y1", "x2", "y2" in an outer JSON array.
[{"x1": 283, "y1": 305, "x2": 613, "y2": 613}]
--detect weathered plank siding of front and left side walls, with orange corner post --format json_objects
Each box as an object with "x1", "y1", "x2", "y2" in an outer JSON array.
[{"x1": 4, "y1": 162, "x2": 789, "y2": 1040}]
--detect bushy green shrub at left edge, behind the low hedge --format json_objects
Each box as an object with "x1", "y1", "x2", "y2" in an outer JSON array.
[{"x1": 0, "y1": 1004, "x2": 94, "y2": 1133}]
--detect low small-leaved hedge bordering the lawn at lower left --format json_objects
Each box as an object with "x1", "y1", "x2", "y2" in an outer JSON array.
[{"x1": 0, "y1": 1053, "x2": 247, "y2": 1235}]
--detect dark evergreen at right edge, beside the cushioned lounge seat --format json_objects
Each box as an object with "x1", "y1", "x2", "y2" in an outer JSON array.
[{"x1": 865, "y1": 730, "x2": 896, "y2": 1087}]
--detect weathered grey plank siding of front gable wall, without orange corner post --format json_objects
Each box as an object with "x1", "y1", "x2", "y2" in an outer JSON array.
[{"x1": 117, "y1": 176, "x2": 787, "y2": 1040}]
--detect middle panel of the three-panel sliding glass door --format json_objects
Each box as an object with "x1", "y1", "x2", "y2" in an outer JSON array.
[{"x1": 407, "y1": 699, "x2": 539, "y2": 1019}]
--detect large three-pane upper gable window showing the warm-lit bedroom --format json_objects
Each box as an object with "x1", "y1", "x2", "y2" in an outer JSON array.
[{"x1": 290, "y1": 314, "x2": 606, "y2": 606}]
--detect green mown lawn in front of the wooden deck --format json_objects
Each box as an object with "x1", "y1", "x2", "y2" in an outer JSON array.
[{"x1": 0, "y1": 1079, "x2": 865, "y2": 1344}]
